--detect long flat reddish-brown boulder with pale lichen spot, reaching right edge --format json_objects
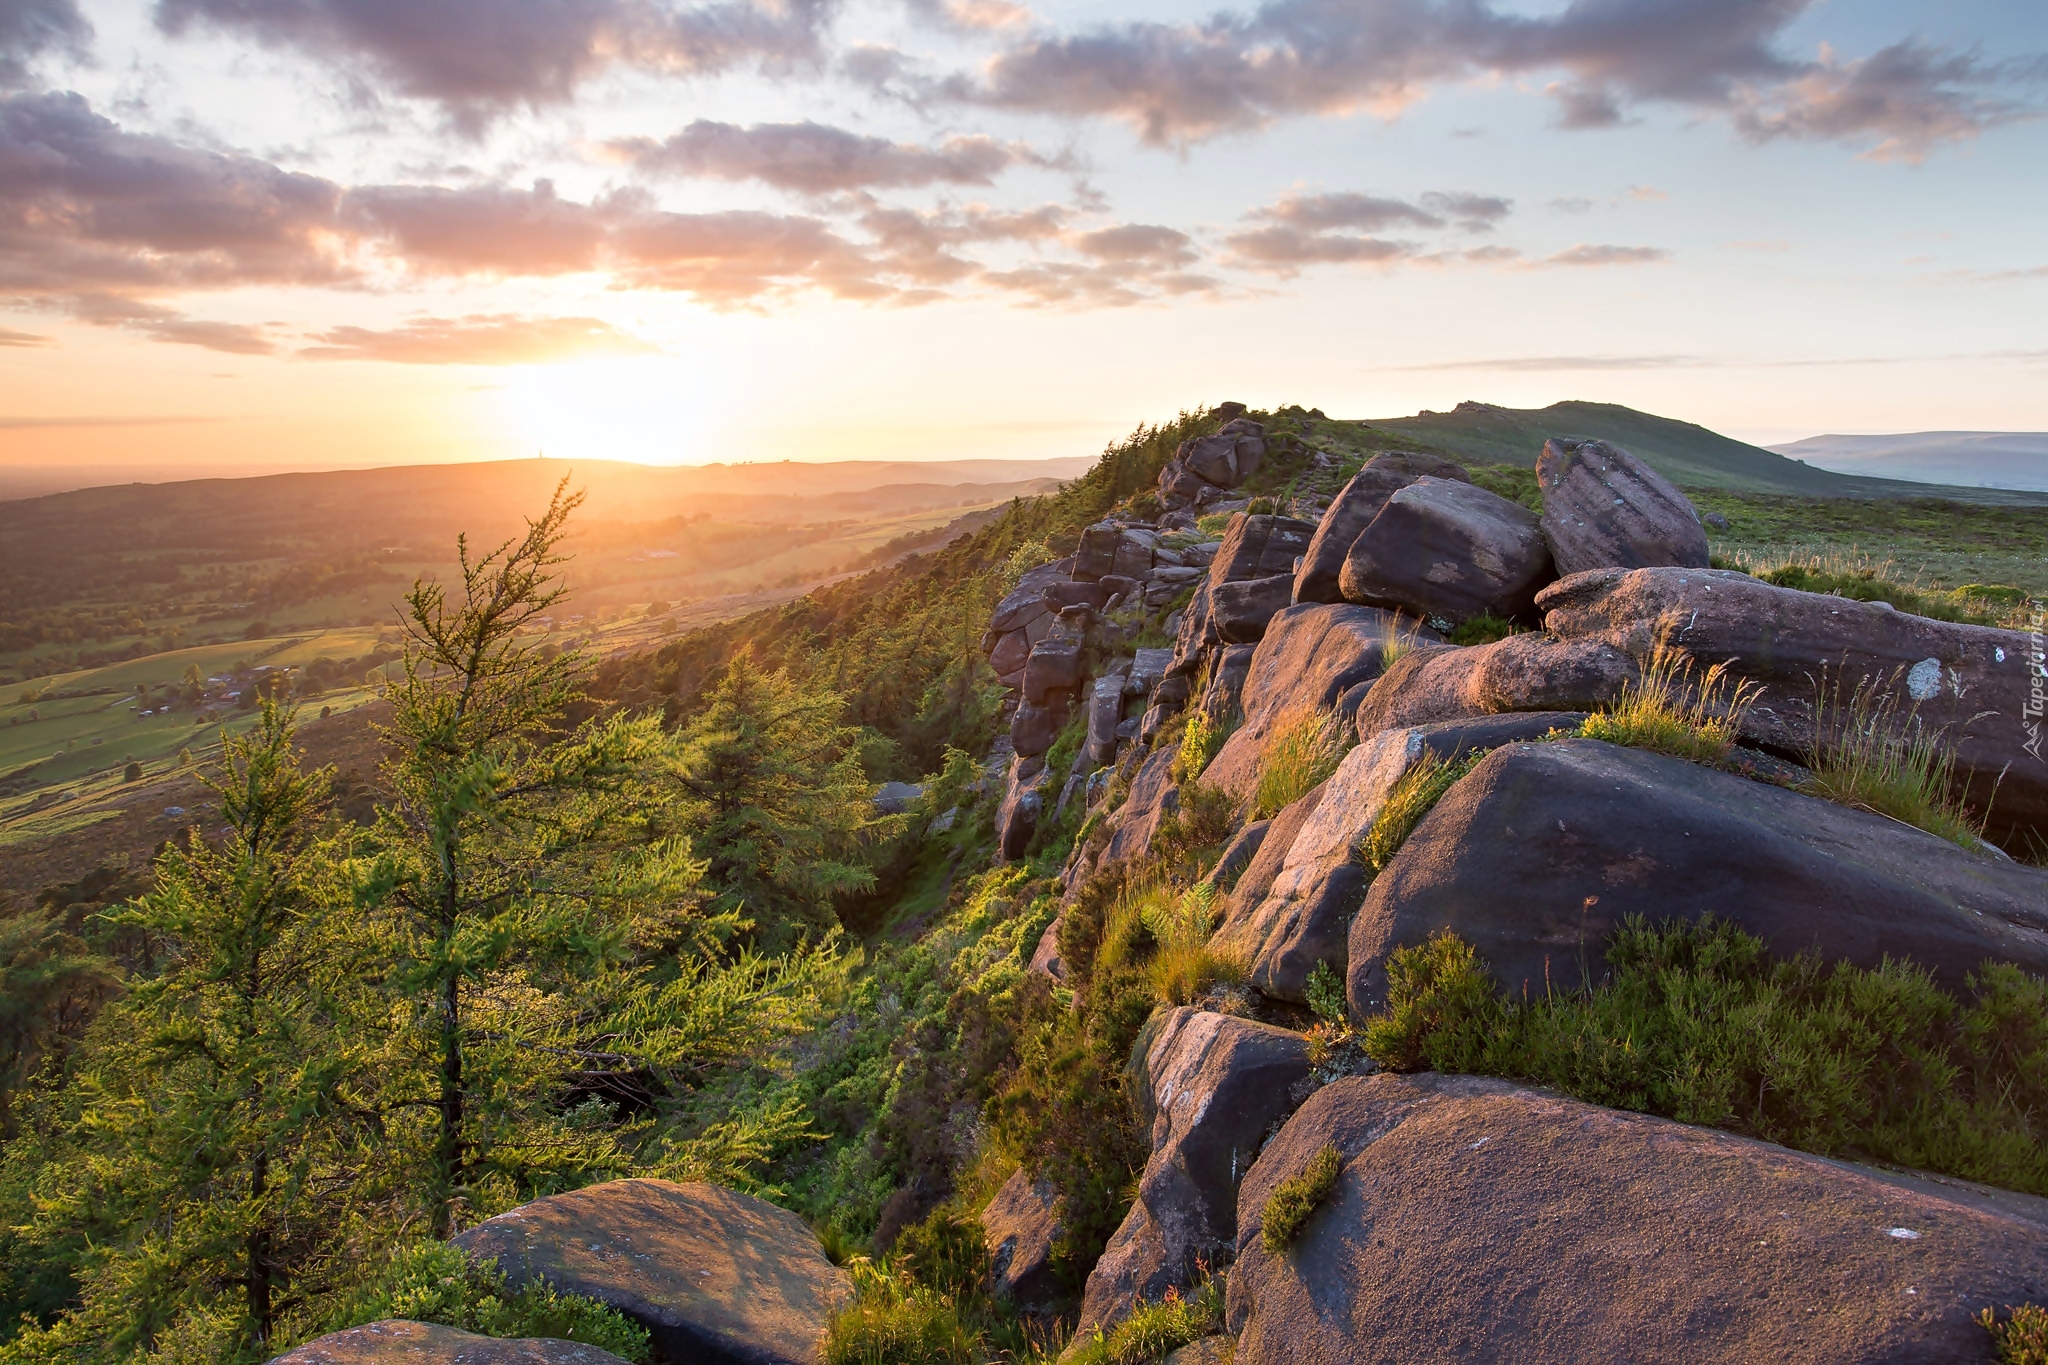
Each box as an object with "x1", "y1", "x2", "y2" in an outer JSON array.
[{"x1": 1538, "y1": 569, "x2": 2048, "y2": 841}]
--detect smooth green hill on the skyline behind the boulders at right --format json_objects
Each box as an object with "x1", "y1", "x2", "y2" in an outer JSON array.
[{"x1": 1372, "y1": 401, "x2": 2032, "y2": 501}]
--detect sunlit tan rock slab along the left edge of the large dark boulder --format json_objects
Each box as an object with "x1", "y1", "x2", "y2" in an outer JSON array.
[{"x1": 1212, "y1": 712, "x2": 1581, "y2": 1003}]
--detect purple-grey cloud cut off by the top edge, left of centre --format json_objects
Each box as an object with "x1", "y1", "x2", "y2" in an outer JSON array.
[{"x1": 156, "y1": 0, "x2": 834, "y2": 133}]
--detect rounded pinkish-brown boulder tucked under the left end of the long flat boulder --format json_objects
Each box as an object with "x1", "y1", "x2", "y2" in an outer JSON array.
[{"x1": 1352, "y1": 632, "x2": 1638, "y2": 737}]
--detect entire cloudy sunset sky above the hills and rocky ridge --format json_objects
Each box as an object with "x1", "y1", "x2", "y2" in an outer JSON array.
[{"x1": 0, "y1": 0, "x2": 2048, "y2": 481}]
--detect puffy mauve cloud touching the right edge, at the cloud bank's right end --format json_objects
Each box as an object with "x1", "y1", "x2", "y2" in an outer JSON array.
[{"x1": 1735, "y1": 39, "x2": 2042, "y2": 164}]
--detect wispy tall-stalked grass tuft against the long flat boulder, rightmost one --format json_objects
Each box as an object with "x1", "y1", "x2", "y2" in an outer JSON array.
[{"x1": 1800, "y1": 673, "x2": 1985, "y2": 849}]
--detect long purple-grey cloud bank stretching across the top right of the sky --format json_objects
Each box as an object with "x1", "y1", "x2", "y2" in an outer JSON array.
[{"x1": 917, "y1": 0, "x2": 2034, "y2": 151}]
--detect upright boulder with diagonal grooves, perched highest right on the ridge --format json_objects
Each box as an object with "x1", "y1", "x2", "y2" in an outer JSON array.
[{"x1": 1536, "y1": 438, "x2": 1706, "y2": 575}]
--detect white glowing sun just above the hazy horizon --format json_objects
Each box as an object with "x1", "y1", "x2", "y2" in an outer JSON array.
[{"x1": 498, "y1": 356, "x2": 715, "y2": 465}]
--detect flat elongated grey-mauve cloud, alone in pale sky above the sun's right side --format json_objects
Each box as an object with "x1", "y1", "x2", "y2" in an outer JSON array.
[{"x1": 610, "y1": 119, "x2": 1024, "y2": 194}]
